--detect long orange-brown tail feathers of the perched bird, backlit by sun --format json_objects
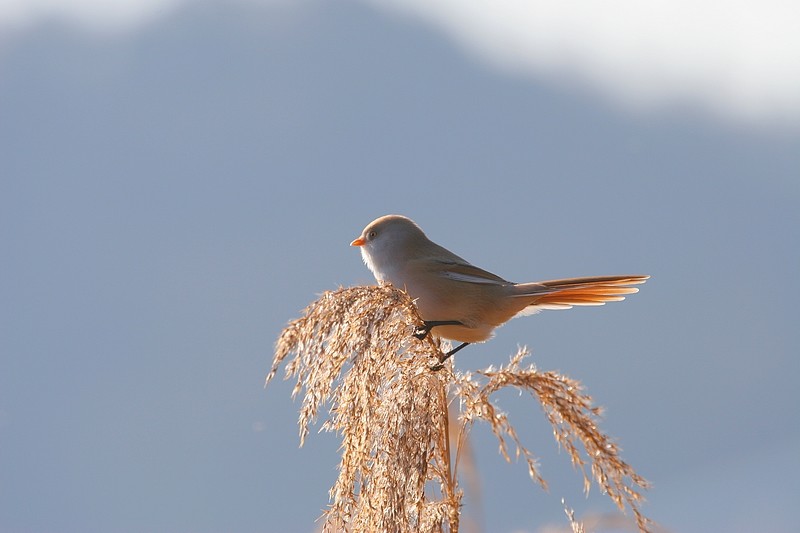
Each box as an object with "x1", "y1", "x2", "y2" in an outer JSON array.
[{"x1": 514, "y1": 275, "x2": 650, "y2": 314}]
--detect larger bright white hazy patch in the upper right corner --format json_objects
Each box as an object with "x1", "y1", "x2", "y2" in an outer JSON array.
[{"x1": 370, "y1": 0, "x2": 800, "y2": 123}]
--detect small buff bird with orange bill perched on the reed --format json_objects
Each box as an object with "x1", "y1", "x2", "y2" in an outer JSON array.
[{"x1": 350, "y1": 215, "x2": 650, "y2": 369}]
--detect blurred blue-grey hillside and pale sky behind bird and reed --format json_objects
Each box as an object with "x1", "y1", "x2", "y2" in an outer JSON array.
[{"x1": 0, "y1": 0, "x2": 800, "y2": 532}]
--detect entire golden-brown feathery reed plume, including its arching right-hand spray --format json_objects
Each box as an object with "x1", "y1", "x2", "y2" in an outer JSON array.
[{"x1": 266, "y1": 285, "x2": 650, "y2": 532}]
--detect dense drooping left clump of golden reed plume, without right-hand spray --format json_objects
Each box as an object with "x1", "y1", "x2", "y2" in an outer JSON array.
[{"x1": 267, "y1": 286, "x2": 460, "y2": 531}]
